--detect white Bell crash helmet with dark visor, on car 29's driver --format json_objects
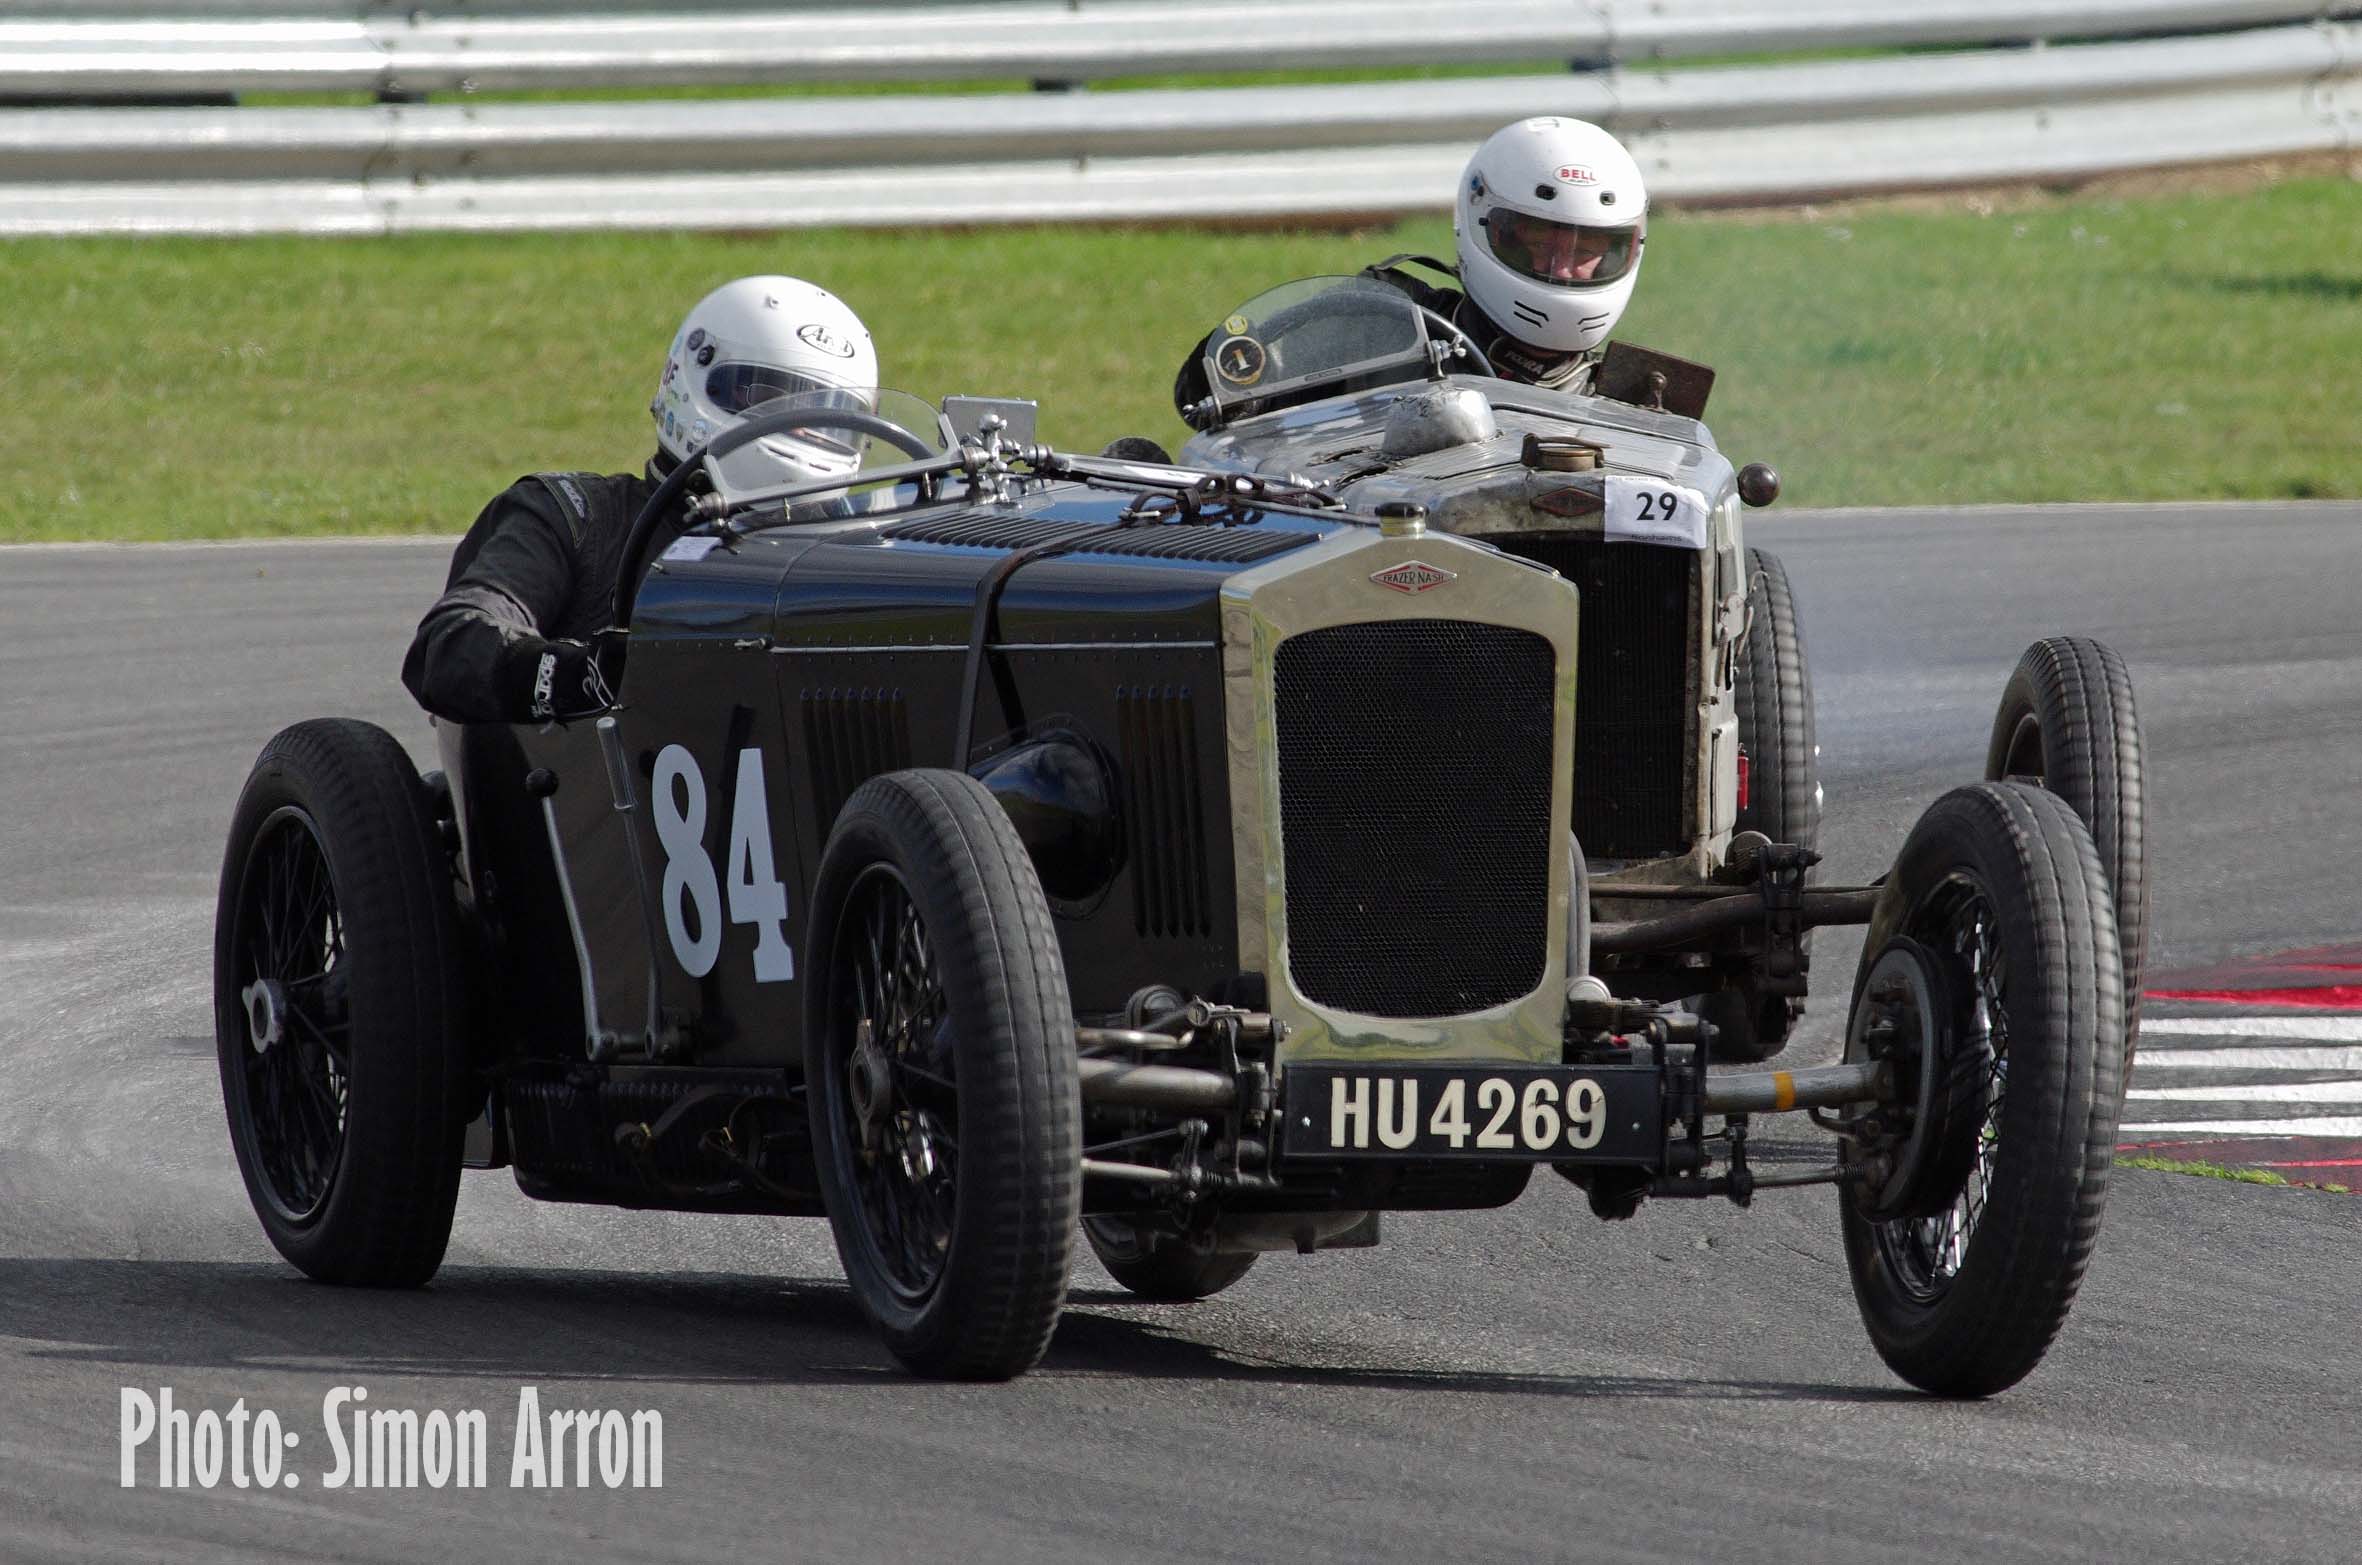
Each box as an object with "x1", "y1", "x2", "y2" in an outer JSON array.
[{"x1": 1453, "y1": 118, "x2": 1649, "y2": 354}]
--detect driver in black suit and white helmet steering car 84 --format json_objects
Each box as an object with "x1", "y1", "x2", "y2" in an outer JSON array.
[{"x1": 402, "y1": 276, "x2": 879, "y2": 722}]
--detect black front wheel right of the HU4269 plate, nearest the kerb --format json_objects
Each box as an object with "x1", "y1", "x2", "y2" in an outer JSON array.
[{"x1": 1840, "y1": 784, "x2": 2123, "y2": 1397}]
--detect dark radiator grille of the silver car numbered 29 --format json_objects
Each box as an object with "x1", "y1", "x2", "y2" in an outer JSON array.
[{"x1": 1486, "y1": 533, "x2": 1698, "y2": 859}]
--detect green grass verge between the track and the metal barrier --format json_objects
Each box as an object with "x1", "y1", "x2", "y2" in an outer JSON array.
[{"x1": 0, "y1": 177, "x2": 2362, "y2": 541}]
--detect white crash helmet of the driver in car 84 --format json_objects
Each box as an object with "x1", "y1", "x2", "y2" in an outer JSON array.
[{"x1": 647, "y1": 276, "x2": 879, "y2": 482}]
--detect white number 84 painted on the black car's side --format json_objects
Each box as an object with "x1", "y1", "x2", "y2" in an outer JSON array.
[{"x1": 654, "y1": 744, "x2": 796, "y2": 984}]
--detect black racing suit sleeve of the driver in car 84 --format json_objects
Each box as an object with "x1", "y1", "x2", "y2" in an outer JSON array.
[{"x1": 402, "y1": 479, "x2": 581, "y2": 722}]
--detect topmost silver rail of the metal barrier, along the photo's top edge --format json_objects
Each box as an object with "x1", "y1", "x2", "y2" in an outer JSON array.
[{"x1": 0, "y1": 0, "x2": 2331, "y2": 97}]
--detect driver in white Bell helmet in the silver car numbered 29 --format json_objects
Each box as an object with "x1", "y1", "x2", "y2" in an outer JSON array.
[{"x1": 1174, "y1": 116, "x2": 1649, "y2": 406}]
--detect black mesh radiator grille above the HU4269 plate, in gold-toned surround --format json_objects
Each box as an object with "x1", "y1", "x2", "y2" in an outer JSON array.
[{"x1": 1275, "y1": 618, "x2": 1564, "y2": 1017}]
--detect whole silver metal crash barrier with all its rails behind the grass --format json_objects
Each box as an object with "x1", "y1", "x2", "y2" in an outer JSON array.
[{"x1": 0, "y1": 0, "x2": 2362, "y2": 234}]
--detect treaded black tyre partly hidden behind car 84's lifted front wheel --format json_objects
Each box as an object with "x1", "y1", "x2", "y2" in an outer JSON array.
[{"x1": 1984, "y1": 635, "x2": 2149, "y2": 1048}]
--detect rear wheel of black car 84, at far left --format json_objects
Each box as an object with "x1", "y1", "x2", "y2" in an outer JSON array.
[{"x1": 213, "y1": 720, "x2": 470, "y2": 1286}]
